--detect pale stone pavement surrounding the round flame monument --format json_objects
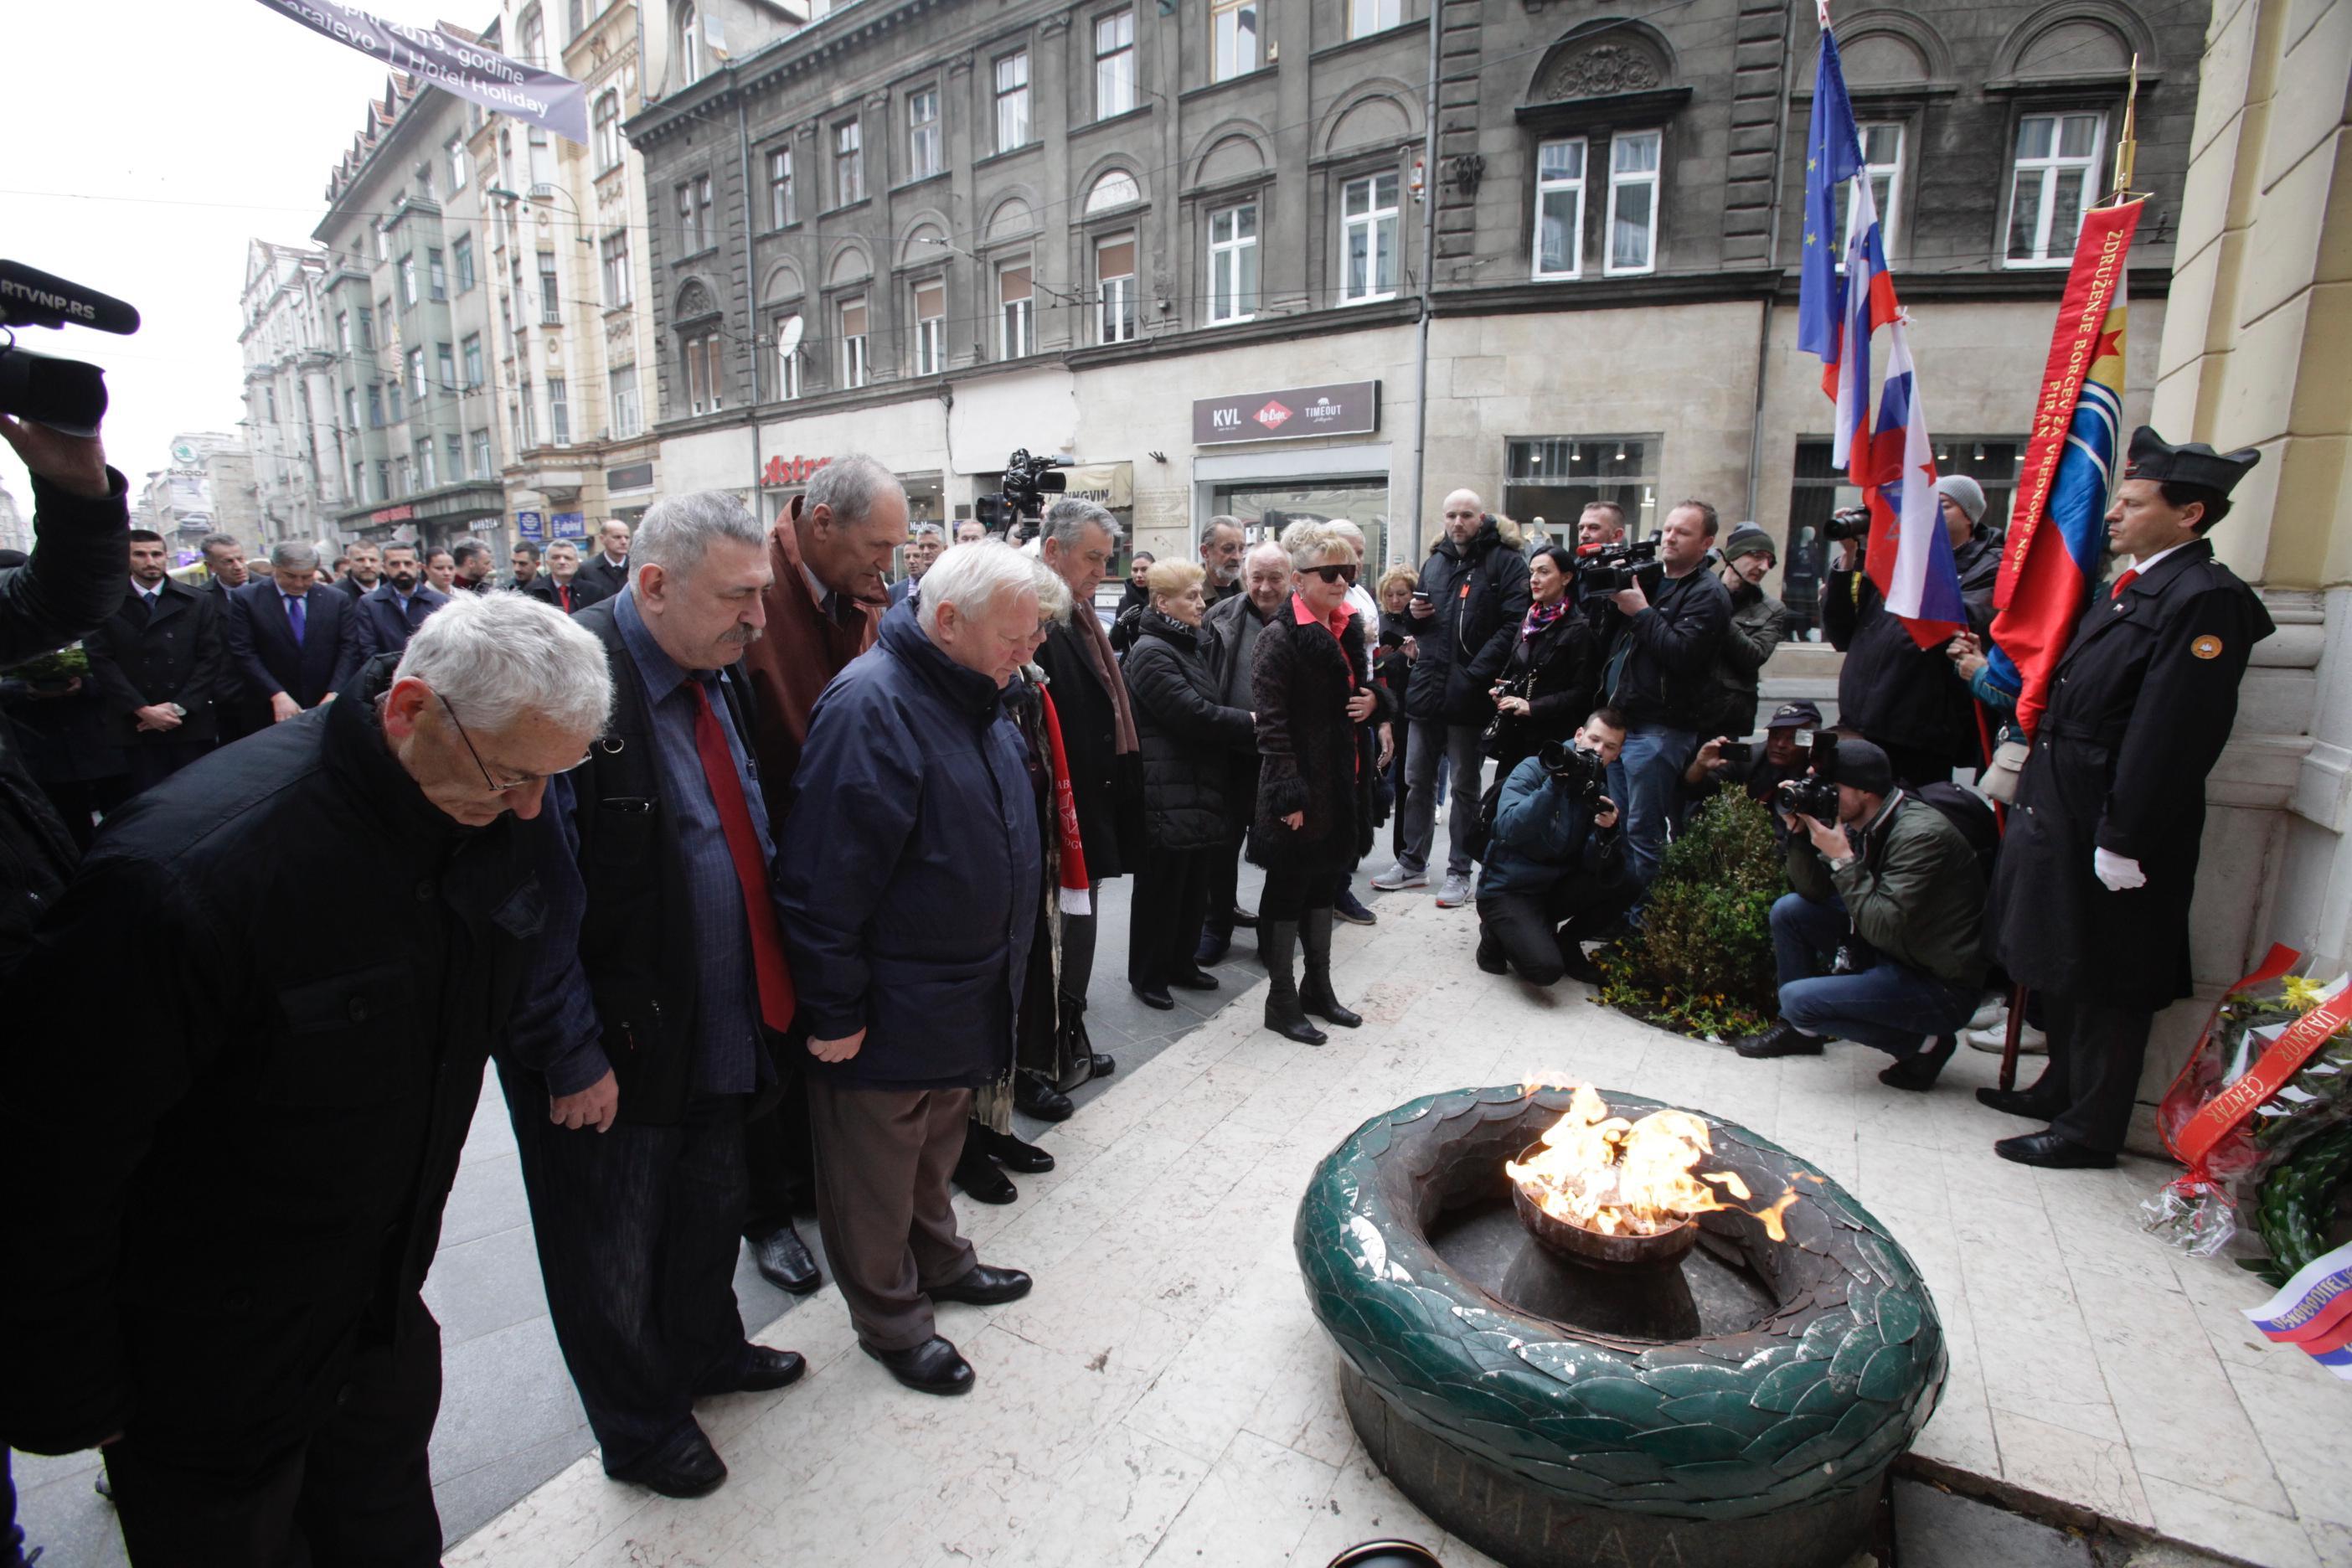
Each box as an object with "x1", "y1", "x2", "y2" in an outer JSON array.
[{"x1": 449, "y1": 895, "x2": 2352, "y2": 1568}]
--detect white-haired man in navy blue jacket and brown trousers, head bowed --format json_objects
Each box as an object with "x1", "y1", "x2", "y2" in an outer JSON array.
[{"x1": 781, "y1": 541, "x2": 1044, "y2": 1394}]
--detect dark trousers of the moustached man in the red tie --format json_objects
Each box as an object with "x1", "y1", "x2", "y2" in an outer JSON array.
[{"x1": 498, "y1": 1063, "x2": 750, "y2": 1472}]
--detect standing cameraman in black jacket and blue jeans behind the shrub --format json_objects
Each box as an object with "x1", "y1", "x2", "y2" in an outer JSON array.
[{"x1": 1602, "y1": 501, "x2": 1731, "y2": 886}]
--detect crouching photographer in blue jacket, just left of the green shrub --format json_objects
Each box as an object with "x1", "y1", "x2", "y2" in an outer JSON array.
[{"x1": 1477, "y1": 708, "x2": 1635, "y2": 985}]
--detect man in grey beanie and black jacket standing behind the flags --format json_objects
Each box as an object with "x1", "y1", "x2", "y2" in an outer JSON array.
[{"x1": 1820, "y1": 475, "x2": 2002, "y2": 785}]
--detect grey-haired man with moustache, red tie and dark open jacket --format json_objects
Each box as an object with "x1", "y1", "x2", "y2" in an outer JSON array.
[{"x1": 501, "y1": 492, "x2": 804, "y2": 1498}]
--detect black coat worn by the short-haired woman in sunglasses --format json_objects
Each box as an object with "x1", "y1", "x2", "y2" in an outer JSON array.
[{"x1": 1249, "y1": 597, "x2": 1395, "y2": 877}]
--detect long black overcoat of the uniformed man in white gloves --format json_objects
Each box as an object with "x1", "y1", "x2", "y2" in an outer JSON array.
[{"x1": 1990, "y1": 539, "x2": 2272, "y2": 1011}]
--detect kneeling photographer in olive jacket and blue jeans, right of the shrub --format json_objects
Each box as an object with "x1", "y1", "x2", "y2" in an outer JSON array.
[{"x1": 1738, "y1": 734, "x2": 1985, "y2": 1088}]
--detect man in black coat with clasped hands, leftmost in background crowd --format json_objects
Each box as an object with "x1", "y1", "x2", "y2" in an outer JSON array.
[{"x1": 82, "y1": 529, "x2": 230, "y2": 808}]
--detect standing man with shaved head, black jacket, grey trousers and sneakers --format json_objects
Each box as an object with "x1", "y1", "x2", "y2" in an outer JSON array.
[{"x1": 1371, "y1": 489, "x2": 1531, "y2": 910}]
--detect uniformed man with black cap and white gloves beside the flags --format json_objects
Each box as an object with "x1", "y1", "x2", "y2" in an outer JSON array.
[{"x1": 1976, "y1": 426, "x2": 2272, "y2": 1168}]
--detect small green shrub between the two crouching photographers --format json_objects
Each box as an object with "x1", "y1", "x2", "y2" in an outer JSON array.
[{"x1": 1599, "y1": 790, "x2": 1787, "y2": 1039}]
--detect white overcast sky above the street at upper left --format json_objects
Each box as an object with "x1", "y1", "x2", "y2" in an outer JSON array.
[{"x1": 0, "y1": 0, "x2": 467, "y2": 505}]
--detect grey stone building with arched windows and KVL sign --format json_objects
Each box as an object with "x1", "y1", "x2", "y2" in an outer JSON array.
[{"x1": 628, "y1": 0, "x2": 2199, "y2": 620}]
